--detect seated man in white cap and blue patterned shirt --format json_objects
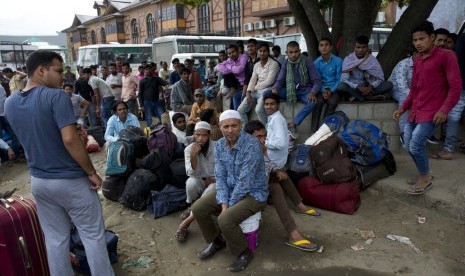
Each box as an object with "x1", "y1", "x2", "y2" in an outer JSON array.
[{"x1": 192, "y1": 110, "x2": 268, "y2": 272}]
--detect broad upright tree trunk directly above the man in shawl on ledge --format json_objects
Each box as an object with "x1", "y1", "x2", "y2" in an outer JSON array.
[{"x1": 339, "y1": 0, "x2": 381, "y2": 57}]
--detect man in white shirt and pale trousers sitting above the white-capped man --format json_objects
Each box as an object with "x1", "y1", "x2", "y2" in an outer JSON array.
[{"x1": 237, "y1": 43, "x2": 279, "y2": 126}]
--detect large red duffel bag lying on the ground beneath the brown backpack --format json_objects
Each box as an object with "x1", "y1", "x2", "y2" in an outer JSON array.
[{"x1": 297, "y1": 176, "x2": 360, "y2": 215}]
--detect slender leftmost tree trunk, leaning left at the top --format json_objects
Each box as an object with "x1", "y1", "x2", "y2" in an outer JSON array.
[{"x1": 287, "y1": 0, "x2": 318, "y2": 59}]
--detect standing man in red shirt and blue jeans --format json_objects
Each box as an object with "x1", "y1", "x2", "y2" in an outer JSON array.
[{"x1": 393, "y1": 21, "x2": 462, "y2": 194}]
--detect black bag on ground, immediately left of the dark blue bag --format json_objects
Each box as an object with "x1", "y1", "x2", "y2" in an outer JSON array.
[{"x1": 119, "y1": 169, "x2": 160, "y2": 211}]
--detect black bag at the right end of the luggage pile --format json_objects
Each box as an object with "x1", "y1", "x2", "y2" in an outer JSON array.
[{"x1": 356, "y1": 151, "x2": 397, "y2": 190}]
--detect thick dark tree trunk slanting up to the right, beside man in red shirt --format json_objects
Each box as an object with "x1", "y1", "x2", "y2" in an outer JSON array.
[{"x1": 377, "y1": 0, "x2": 438, "y2": 78}]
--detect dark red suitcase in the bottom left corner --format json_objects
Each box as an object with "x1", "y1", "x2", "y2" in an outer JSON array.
[{"x1": 0, "y1": 195, "x2": 50, "y2": 276}]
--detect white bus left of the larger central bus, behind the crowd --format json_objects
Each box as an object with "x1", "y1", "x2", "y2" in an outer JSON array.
[{"x1": 77, "y1": 44, "x2": 152, "y2": 71}]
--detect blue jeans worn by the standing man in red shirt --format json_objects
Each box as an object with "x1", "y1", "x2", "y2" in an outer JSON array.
[{"x1": 404, "y1": 122, "x2": 434, "y2": 175}]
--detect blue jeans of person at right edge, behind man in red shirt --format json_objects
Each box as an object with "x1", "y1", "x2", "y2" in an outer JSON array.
[{"x1": 443, "y1": 90, "x2": 465, "y2": 152}]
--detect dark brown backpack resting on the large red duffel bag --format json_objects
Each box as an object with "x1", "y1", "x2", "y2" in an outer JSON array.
[{"x1": 310, "y1": 136, "x2": 357, "y2": 183}]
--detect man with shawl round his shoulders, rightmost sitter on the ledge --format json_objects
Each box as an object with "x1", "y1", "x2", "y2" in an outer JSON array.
[{"x1": 337, "y1": 35, "x2": 392, "y2": 101}]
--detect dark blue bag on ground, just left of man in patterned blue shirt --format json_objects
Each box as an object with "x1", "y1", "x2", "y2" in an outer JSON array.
[{"x1": 150, "y1": 184, "x2": 187, "y2": 218}]
